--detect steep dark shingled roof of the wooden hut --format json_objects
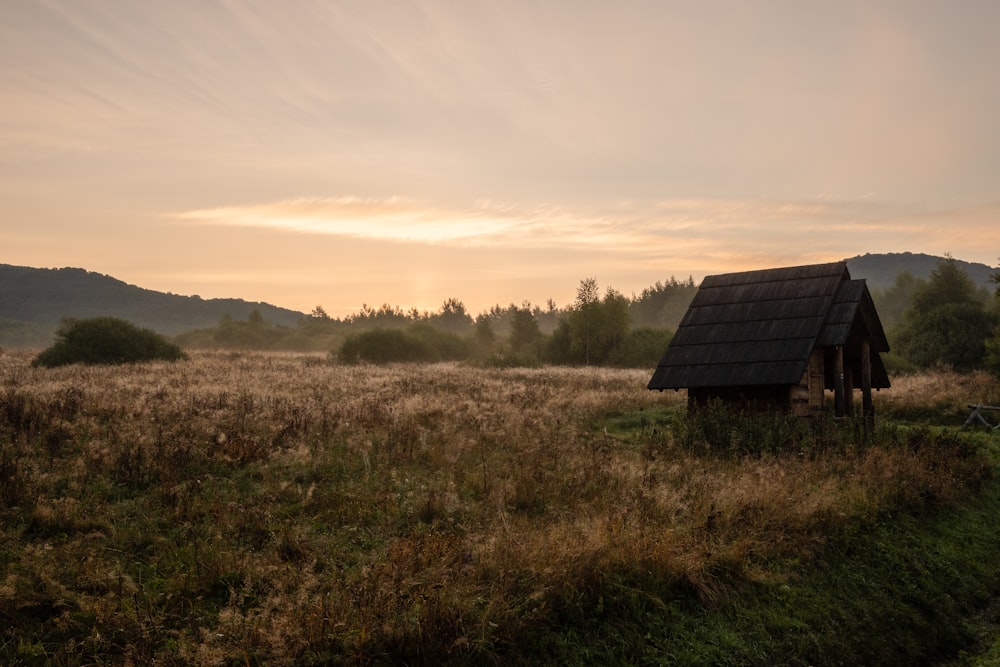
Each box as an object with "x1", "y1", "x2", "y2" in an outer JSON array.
[{"x1": 649, "y1": 262, "x2": 889, "y2": 389}]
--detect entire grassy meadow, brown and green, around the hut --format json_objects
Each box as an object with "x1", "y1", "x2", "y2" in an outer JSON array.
[{"x1": 0, "y1": 351, "x2": 1000, "y2": 665}]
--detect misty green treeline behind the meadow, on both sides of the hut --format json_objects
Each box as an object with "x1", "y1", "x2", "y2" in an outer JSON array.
[{"x1": 175, "y1": 256, "x2": 1000, "y2": 374}]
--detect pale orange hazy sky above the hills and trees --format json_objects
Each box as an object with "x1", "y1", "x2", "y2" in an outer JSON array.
[{"x1": 0, "y1": 0, "x2": 1000, "y2": 317}]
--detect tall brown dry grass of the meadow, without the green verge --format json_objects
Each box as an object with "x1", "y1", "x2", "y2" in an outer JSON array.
[{"x1": 0, "y1": 352, "x2": 996, "y2": 664}]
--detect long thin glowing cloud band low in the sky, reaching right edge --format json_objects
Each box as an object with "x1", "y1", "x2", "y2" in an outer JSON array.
[{"x1": 173, "y1": 196, "x2": 1000, "y2": 266}]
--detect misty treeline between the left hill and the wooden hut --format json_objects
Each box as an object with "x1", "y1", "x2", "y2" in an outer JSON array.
[{"x1": 174, "y1": 277, "x2": 697, "y2": 366}]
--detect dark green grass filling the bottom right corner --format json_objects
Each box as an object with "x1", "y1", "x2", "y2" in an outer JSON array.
[{"x1": 508, "y1": 474, "x2": 1000, "y2": 665}]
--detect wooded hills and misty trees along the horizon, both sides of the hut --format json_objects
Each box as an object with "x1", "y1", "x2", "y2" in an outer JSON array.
[{"x1": 0, "y1": 253, "x2": 1000, "y2": 371}]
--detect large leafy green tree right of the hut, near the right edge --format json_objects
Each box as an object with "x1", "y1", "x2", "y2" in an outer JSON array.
[{"x1": 896, "y1": 256, "x2": 997, "y2": 370}]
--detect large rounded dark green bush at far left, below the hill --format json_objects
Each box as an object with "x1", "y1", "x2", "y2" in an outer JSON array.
[{"x1": 31, "y1": 317, "x2": 187, "y2": 368}]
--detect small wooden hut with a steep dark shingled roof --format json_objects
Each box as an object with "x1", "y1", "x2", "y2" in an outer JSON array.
[{"x1": 648, "y1": 262, "x2": 889, "y2": 416}]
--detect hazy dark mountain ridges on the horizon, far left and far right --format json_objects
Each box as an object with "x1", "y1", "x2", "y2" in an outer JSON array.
[{"x1": 0, "y1": 252, "x2": 996, "y2": 347}]
